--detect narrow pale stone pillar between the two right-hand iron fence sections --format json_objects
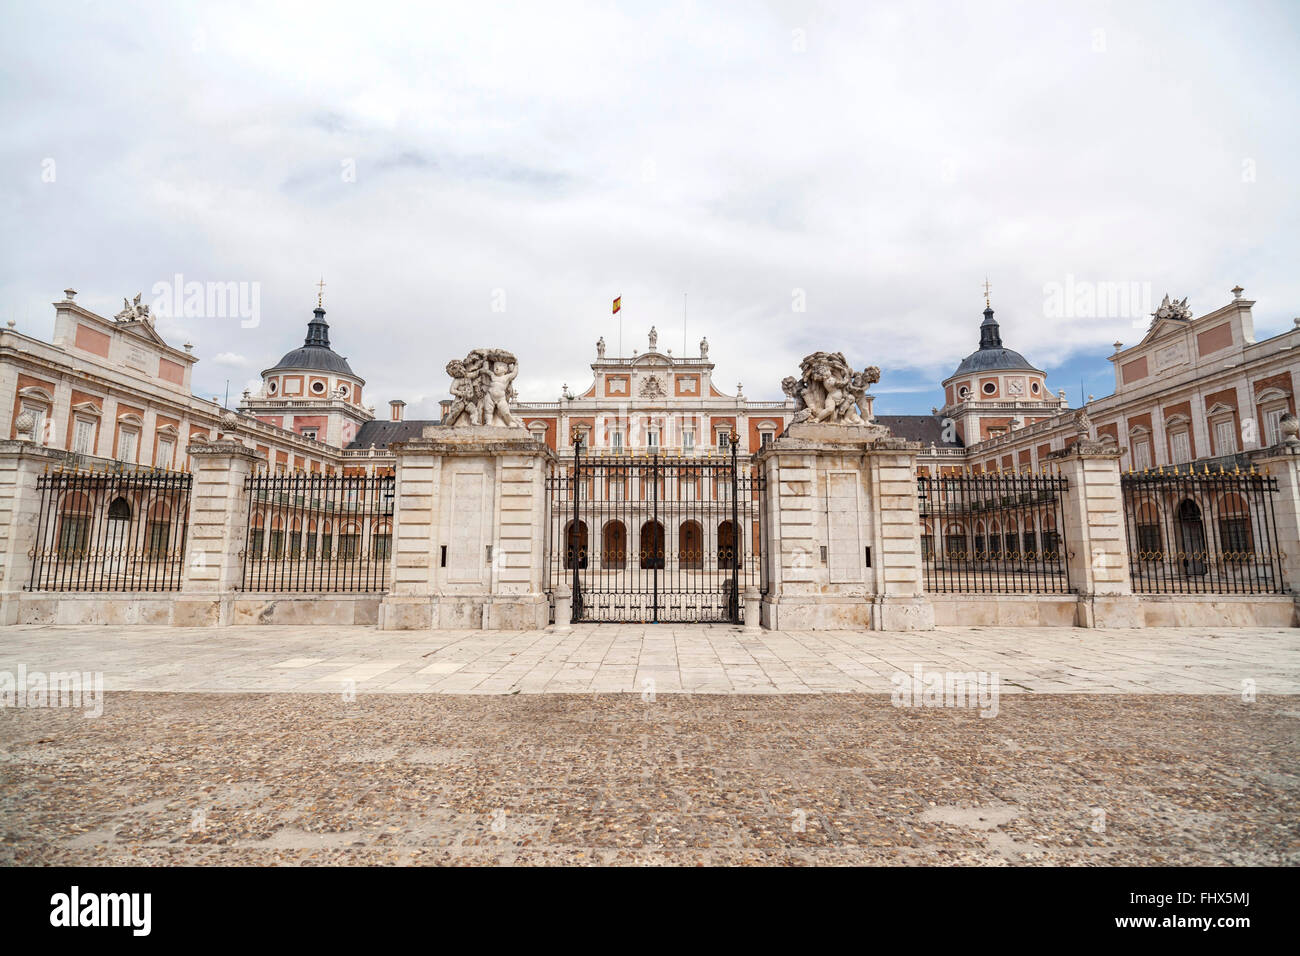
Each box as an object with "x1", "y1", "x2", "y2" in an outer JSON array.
[{"x1": 1047, "y1": 438, "x2": 1144, "y2": 627}]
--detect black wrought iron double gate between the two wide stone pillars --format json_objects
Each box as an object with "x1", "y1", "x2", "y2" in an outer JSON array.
[{"x1": 546, "y1": 434, "x2": 767, "y2": 623}]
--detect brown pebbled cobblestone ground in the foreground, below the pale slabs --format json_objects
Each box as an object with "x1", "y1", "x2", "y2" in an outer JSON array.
[{"x1": 0, "y1": 697, "x2": 1300, "y2": 865}]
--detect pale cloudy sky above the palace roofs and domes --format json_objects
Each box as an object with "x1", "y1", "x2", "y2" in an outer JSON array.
[{"x1": 0, "y1": 0, "x2": 1300, "y2": 416}]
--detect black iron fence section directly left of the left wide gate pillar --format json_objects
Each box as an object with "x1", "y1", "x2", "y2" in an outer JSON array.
[{"x1": 241, "y1": 475, "x2": 394, "y2": 592}]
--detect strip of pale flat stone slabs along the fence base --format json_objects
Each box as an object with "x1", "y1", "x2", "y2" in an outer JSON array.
[{"x1": 0, "y1": 624, "x2": 1300, "y2": 695}]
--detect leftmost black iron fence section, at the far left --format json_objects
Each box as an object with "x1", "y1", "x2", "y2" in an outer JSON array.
[{"x1": 27, "y1": 470, "x2": 192, "y2": 591}]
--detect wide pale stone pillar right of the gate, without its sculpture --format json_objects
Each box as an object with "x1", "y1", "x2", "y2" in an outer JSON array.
[{"x1": 758, "y1": 423, "x2": 935, "y2": 630}]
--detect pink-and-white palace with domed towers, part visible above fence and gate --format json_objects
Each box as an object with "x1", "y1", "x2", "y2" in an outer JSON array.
[{"x1": 0, "y1": 287, "x2": 1300, "y2": 475}]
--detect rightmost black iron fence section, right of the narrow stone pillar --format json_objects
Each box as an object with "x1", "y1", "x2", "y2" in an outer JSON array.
[{"x1": 1121, "y1": 466, "x2": 1284, "y2": 594}]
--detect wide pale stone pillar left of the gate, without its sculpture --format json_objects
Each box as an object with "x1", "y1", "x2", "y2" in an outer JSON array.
[{"x1": 380, "y1": 425, "x2": 555, "y2": 630}]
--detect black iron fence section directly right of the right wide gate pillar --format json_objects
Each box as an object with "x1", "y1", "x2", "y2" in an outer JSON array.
[{"x1": 917, "y1": 473, "x2": 1073, "y2": 594}]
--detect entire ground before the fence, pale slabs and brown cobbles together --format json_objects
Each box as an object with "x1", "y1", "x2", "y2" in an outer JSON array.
[{"x1": 0, "y1": 626, "x2": 1300, "y2": 865}]
